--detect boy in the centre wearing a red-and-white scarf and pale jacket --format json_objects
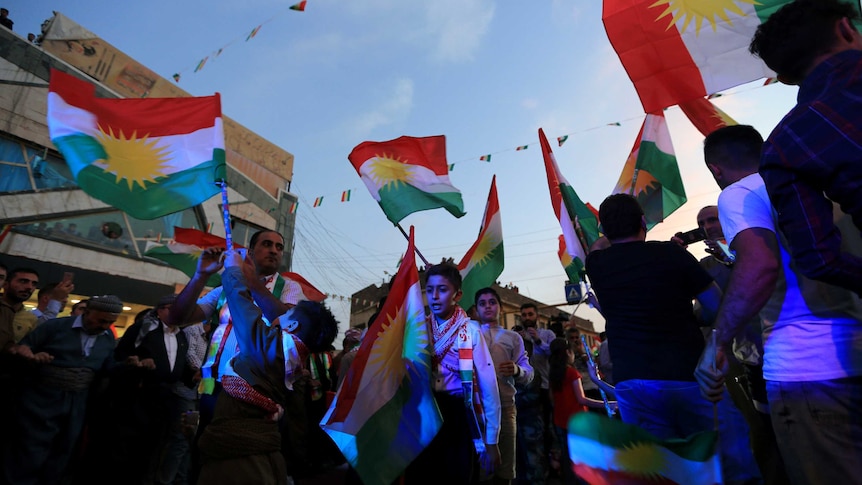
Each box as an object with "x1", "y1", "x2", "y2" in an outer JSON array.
[{"x1": 406, "y1": 263, "x2": 500, "y2": 484}]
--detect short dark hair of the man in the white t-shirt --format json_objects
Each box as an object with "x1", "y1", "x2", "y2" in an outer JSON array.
[{"x1": 703, "y1": 125, "x2": 763, "y2": 170}]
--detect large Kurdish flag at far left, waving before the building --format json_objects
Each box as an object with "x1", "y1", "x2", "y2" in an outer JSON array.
[{"x1": 48, "y1": 70, "x2": 225, "y2": 219}]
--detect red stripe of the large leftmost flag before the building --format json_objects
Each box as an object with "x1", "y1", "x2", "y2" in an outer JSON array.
[{"x1": 50, "y1": 69, "x2": 221, "y2": 137}]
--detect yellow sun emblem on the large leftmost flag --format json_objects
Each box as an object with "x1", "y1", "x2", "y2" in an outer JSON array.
[{"x1": 96, "y1": 126, "x2": 170, "y2": 190}]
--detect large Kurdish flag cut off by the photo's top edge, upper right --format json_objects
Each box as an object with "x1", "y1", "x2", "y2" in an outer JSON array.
[{"x1": 602, "y1": 0, "x2": 792, "y2": 113}]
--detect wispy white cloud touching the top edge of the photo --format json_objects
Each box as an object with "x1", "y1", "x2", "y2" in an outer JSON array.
[{"x1": 425, "y1": 0, "x2": 496, "y2": 62}]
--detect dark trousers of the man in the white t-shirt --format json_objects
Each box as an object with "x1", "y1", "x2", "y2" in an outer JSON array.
[{"x1": 766, "y1": 376, "x2": 862, "y2": 485}]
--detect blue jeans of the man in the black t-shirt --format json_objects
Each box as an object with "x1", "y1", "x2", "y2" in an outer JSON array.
[{"x1": 616, "y1": 379, "x2": 760, "y2": 483}]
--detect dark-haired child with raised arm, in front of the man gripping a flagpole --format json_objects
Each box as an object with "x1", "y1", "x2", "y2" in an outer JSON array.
[{"x1": 198, "y1": 251, "x2": 338, "y2": 484}]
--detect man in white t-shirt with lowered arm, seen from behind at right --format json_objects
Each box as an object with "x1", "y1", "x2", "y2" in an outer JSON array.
[{"x1": 695, "y1": 126, "x2": 862, "y2": 484}]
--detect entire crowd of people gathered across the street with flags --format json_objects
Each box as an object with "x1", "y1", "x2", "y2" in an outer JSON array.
[{"x1": 0, "y1": 0, "x2": 862, "y2": 485}]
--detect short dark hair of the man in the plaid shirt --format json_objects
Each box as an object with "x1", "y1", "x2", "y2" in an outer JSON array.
[{"x1": 748, "y1": 0, "x2": 859, "y2": 84}]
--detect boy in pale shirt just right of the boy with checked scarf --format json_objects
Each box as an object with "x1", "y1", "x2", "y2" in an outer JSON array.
[{"x1": 475, "y1": 288, "x2": 533, "y2": 485}]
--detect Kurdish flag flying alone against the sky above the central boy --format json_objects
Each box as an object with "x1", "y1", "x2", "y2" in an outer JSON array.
[{"x1": 347, "y1": 135, "x2": 464, "y2": 224}]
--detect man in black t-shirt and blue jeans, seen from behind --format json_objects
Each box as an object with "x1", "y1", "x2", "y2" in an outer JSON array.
[{"x1": 586, "y1": 194, "x2": 759, "y2": 483}]
